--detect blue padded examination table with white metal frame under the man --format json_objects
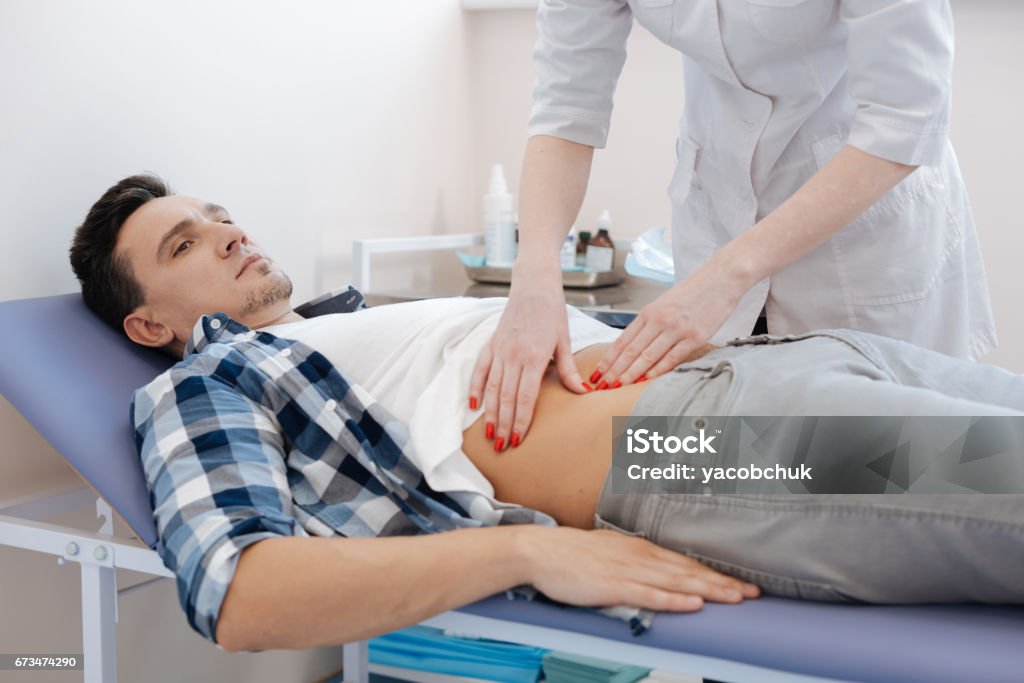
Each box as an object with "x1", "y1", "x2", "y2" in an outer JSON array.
[{"x1": 0, "y1": 294, "x2": 1024, "y2": 683}]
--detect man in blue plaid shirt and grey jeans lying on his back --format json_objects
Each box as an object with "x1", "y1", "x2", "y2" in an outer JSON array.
[{"x1": 71, "y1": 176, "x2": 1024, "y2": 650}]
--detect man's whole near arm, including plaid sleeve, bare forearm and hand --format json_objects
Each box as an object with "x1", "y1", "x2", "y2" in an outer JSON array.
[{"x1": 132, "y1": 371, "x2": 757, "y2": 650}]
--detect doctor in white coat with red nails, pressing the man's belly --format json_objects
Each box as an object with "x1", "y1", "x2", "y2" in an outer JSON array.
[{"x1": 470, "y1": 0, "x2": 996, "y2": 445}]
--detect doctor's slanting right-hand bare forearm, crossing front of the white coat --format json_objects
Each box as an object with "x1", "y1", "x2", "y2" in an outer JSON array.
[{"x1": 715, "y1": 146, "x2": 916, "y2": 288}]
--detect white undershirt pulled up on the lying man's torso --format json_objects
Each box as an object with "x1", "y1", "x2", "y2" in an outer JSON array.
[{"x1": 264, "y1": 297, "x2": 622, "y2": 499}]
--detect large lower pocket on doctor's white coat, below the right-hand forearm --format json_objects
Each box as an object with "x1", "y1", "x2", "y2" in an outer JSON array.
[{"x1": 812, "y1": 135, "x2": 964, "y2": 306}]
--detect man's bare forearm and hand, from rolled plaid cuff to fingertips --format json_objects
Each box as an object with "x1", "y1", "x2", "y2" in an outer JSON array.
[{"x1": 216, "y1": 525, "x2": 758, "y2": 651}]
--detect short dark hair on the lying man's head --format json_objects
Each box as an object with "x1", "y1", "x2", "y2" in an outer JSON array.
[{"x1": 71, "y1": 174, "x2": 174, "y2": 332}]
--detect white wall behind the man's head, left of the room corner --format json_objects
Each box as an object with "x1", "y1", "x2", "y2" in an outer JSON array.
[{"x1": 0, "y1": 0, "x2": 476, "y2": 683}]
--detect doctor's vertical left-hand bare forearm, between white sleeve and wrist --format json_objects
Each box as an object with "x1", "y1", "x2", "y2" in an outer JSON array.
[{"x1": 516, "y1": 135, "x2": 594, "y2": 283}]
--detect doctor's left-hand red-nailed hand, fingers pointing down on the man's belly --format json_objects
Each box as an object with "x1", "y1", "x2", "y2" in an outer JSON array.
[{"x1": 469, "y1": 270, "x2": 587, "y2": 453}]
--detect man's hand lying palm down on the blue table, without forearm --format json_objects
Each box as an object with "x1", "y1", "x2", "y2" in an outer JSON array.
[{"x1": 526, "y1": 526, "x2": 760, "y2": 611}]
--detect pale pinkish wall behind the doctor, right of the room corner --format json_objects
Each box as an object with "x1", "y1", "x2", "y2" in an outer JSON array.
[{"x1": 469, "y1": 0, "x2": 1024, "y2": 373}]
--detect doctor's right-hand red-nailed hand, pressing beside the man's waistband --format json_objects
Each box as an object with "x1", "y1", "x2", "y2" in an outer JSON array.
[{"x1": 585, "y1": 252, "x2": 752, "y2": 389}]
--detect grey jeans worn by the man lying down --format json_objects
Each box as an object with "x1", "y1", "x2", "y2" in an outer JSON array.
[{"x1": 595, "y1": 331, "x2": 1024, "y2": 603}]
